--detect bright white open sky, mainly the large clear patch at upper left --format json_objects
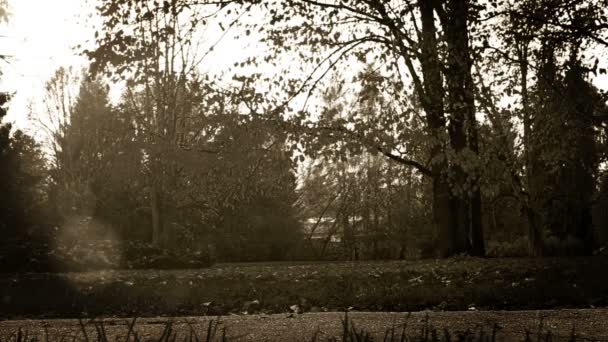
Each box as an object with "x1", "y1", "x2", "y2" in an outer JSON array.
[{"x1": 0, "y1": 0, "x2": 608, "y2": 133}]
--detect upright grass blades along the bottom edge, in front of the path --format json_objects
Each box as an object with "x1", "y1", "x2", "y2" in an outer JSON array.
[{"x1": 0, "y1": 312, "x2": 592, "y2": 342}]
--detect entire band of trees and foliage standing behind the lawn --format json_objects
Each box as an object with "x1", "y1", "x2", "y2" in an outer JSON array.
[{"x1": 5, "y1": 0, "x2": 608, "y2": 260}]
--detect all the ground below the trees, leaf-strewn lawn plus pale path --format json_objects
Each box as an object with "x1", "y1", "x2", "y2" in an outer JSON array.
[{"x1": 0, "y1": 256, "x2": 608, "y2": 340}]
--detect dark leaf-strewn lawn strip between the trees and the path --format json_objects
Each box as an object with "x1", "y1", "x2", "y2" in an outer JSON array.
[{"x1": 0, "y1": 256, "x2": 608, "y2": 318}]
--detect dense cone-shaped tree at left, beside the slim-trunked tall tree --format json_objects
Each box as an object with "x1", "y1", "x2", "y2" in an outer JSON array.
[{"x1": 55, "y1": 75, "x2": 143, "y2": 232}]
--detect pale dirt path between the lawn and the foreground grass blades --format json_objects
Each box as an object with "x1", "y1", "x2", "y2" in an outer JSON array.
[{"x1": 0, "y1": 308, "x2": 608, "y2": 341}]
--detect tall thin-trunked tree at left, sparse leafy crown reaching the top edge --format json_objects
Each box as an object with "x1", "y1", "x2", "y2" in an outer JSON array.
[{"x1": 87, "y1": 0, "x2": 254, "y2": 246}]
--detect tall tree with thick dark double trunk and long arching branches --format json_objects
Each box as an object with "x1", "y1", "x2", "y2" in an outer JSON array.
[{"x1": 247, "y1": 1, "x2": 484, "y2": 256}]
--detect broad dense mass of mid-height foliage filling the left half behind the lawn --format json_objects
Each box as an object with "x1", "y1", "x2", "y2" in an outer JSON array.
[{"x1": 33, "y1": 62, "x2": 299, "y2": 260}]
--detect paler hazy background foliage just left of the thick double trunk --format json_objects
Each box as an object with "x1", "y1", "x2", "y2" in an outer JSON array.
[{"x1": 299, "y1": 154, "x2": 433, "y2": 260}]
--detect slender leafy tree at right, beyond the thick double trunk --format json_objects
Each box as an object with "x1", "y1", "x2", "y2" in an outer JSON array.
[{"x1": 486, "y1": 0, "x2": 605, "y2": 255}]
